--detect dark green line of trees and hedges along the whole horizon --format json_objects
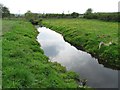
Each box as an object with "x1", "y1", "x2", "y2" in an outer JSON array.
[{"x1": 0, "y1": 4, "x2": 120, "y2": 22}]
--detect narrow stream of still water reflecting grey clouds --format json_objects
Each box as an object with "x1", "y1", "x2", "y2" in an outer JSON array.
[{"x1": 37, "y1": 27, "x2": 118, "y2": 88}]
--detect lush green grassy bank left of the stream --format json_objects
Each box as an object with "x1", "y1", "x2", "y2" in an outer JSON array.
[{"x1": 2, "y1": 20, "x2": 86, "y2": 88}]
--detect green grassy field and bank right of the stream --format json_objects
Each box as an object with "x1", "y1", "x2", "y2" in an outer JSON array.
[{"x1": 43, "y1": 19, "x2": 120, "y2": 69}]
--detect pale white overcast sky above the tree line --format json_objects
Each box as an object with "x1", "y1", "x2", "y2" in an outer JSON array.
[{"x1": 0, "y1": 0, "x2": 120, "y2": 14}]
